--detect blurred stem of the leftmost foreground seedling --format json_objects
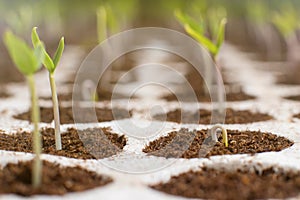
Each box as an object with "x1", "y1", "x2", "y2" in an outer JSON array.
[{"x1": 27, "y1": 75, "x2": 42, "y2": 188}]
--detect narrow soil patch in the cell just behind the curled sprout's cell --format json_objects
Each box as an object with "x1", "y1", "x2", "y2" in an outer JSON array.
[{"x1": 154, "y1": 108, "x2": 273, "y2": 124}]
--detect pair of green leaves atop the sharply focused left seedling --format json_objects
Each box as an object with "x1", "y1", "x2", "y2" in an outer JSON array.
[{"x1": 31, "y1": 27, "x2": 65, "y2": 73}]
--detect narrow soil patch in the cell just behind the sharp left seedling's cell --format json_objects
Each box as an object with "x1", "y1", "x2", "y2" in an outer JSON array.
[{"x1": 14, "y1": 107, "x2": 131, "y2": 124}]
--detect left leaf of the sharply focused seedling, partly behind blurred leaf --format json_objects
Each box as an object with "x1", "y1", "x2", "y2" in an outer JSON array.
[{"x1": 31, "y1": 27, "x2": 55, "y2": 73}]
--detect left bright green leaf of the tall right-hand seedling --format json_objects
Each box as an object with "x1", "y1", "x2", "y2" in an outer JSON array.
[{"x1": 184, "y1": 24, "x2": 218, "y2": 56}]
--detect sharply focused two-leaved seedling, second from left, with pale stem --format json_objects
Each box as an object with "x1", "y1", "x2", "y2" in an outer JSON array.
[{"x1": 31, "y1": 27, "x2": 64, "y2": 150}]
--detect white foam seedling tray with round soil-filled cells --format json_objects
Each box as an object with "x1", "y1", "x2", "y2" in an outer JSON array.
[{"x1": 0, "y1": 44, "x2": 300, "y2": 200}]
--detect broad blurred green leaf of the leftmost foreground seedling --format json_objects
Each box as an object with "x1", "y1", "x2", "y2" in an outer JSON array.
[{"x1": 4, "y1": 31, "x2": 41, "y2": 76}]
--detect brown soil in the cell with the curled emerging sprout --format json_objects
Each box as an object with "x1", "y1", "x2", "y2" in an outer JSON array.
[{"x1": 143, "y1": 129, "x2": 294, "y2": 159}]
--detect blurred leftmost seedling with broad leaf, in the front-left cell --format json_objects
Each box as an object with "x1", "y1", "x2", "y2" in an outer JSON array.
[{"x1": 4, "y1": 31, "x2": 44, "y2": 188}]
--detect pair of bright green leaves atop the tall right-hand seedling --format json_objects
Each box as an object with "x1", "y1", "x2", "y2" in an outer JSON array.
[{"x1": 175, "y1": 10, "x2": 227, "y2": 57}]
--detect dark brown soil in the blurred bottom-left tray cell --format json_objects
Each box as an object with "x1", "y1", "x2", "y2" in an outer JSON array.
[{"x1": 0, "y1": 161, "x2": 112, "y2": 196}]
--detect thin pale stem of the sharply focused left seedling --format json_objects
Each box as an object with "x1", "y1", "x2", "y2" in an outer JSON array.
[{"x1": 49, "y1": 73, "x2": 62, "y2": 150}]
